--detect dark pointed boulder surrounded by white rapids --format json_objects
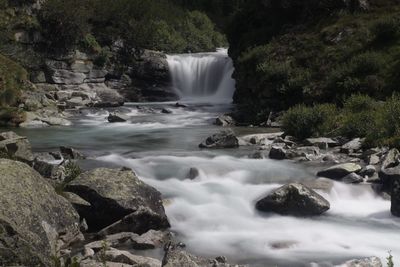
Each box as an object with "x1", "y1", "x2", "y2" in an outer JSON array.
[{"x1": 256, "y1": 183, "x2": 330, "y2": 216}]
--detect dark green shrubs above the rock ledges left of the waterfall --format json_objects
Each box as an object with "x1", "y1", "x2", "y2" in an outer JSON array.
[{"x1": 39, "y1": 0, "x2": 226, "y2": 54}]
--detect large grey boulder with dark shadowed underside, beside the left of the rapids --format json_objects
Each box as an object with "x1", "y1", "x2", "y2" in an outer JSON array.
[{"x1": 66, "y1": 168, "x2": 169, "y2": 234}]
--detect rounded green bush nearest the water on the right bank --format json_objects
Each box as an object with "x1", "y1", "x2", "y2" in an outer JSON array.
[{"x1": 282, "y1": 104, "x2": 337, "y2": 140}]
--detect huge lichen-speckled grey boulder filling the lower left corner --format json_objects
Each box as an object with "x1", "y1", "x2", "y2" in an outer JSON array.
[{"x1": 0, "y1": 159, "x2": 81, "y2": 266}]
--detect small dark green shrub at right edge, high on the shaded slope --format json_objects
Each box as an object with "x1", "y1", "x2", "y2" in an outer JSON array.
[{"x1": 371, "y1": 17, "x2": 400, "y2": 43}]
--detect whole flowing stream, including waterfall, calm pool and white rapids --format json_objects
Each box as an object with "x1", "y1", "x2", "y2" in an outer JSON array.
[{"x1": 12, "y1": 51, "x2": 400, "y2": 266}]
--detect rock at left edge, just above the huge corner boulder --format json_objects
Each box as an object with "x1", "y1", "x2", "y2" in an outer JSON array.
[{"x1": 0, "y1": 132, "x2": 33, "y2": 163}]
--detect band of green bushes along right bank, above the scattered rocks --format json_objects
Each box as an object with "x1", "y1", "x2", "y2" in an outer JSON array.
[{"x1": 282, "y1": 94, "x2": 400, "y2": 148}]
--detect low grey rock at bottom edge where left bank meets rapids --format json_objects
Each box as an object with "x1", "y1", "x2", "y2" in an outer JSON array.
[{"x1": 162, "y1": 243, "x2": 245, "y2": 267}]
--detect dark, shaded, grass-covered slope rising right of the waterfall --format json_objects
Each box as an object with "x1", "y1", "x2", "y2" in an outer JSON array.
[{"x1": 229, "y1": 0, "x2": 400, "y2": 123}]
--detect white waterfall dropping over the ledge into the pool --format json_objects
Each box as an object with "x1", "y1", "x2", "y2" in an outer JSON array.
[{"x1": 167, "y1": 49, "x2": 235, "y2": 102}]
